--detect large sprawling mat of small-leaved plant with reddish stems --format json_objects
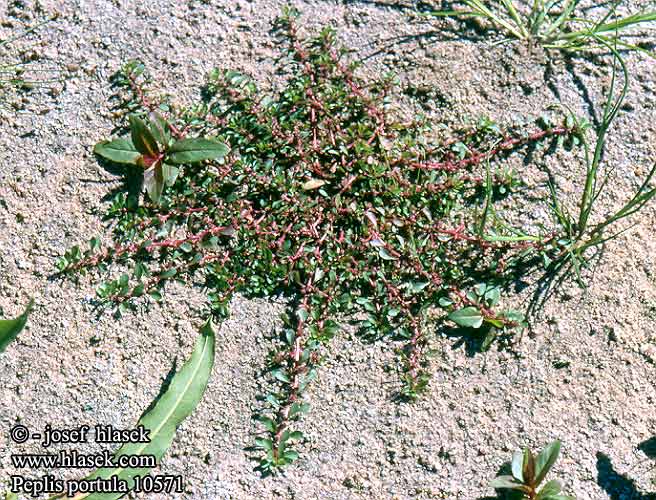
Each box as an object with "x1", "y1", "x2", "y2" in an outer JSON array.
[{"x1": 59, "y1": 11, "x2": 596, "y2": 471}]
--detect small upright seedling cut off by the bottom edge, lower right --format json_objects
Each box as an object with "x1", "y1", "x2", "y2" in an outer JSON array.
[{"x1": 490, "y1": 441, "x2": 576, "y2": 500}]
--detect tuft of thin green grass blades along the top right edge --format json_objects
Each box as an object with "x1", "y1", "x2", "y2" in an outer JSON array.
[{"x1": 429, "y1": 0, "x2": 656, "y2": 57}]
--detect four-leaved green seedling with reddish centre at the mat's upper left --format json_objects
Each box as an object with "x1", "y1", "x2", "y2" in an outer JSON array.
[{"x1": 93, "y1": 113, "x2": 229, "y2": 203}]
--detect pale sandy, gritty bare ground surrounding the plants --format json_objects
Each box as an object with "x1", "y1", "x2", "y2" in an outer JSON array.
[{"x1": 0, "y1": 0, "x2": 656, "y2": 500}]
